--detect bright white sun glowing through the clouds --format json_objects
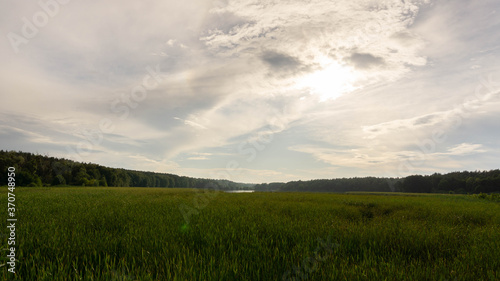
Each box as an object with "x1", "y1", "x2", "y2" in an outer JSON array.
[{"x1": 296, "y1": 60, "x2": 357, "y2": 101}]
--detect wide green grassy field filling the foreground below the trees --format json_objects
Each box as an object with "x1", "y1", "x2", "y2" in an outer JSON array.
[{"x1": 0, "y1": 188, "x2": 500, "y2": 281}]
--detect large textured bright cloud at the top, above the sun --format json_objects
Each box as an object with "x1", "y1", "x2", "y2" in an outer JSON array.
[{"x1": 201, "y1": 0, "x2": 426, "y2": 92}]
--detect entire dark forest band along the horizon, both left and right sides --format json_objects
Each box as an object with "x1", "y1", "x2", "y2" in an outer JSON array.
[{"x1": 0, "y1": 150, "x2": 500, "y2": 194}]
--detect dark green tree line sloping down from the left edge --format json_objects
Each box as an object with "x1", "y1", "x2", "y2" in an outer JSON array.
[{"x1": 0, "y1": 150, "x2": 253, "y2": 190}]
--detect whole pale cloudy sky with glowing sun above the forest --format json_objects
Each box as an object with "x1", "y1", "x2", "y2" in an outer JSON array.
[{"x1": 0, "y1": 0, "x2": 500, "y2": 183}]
